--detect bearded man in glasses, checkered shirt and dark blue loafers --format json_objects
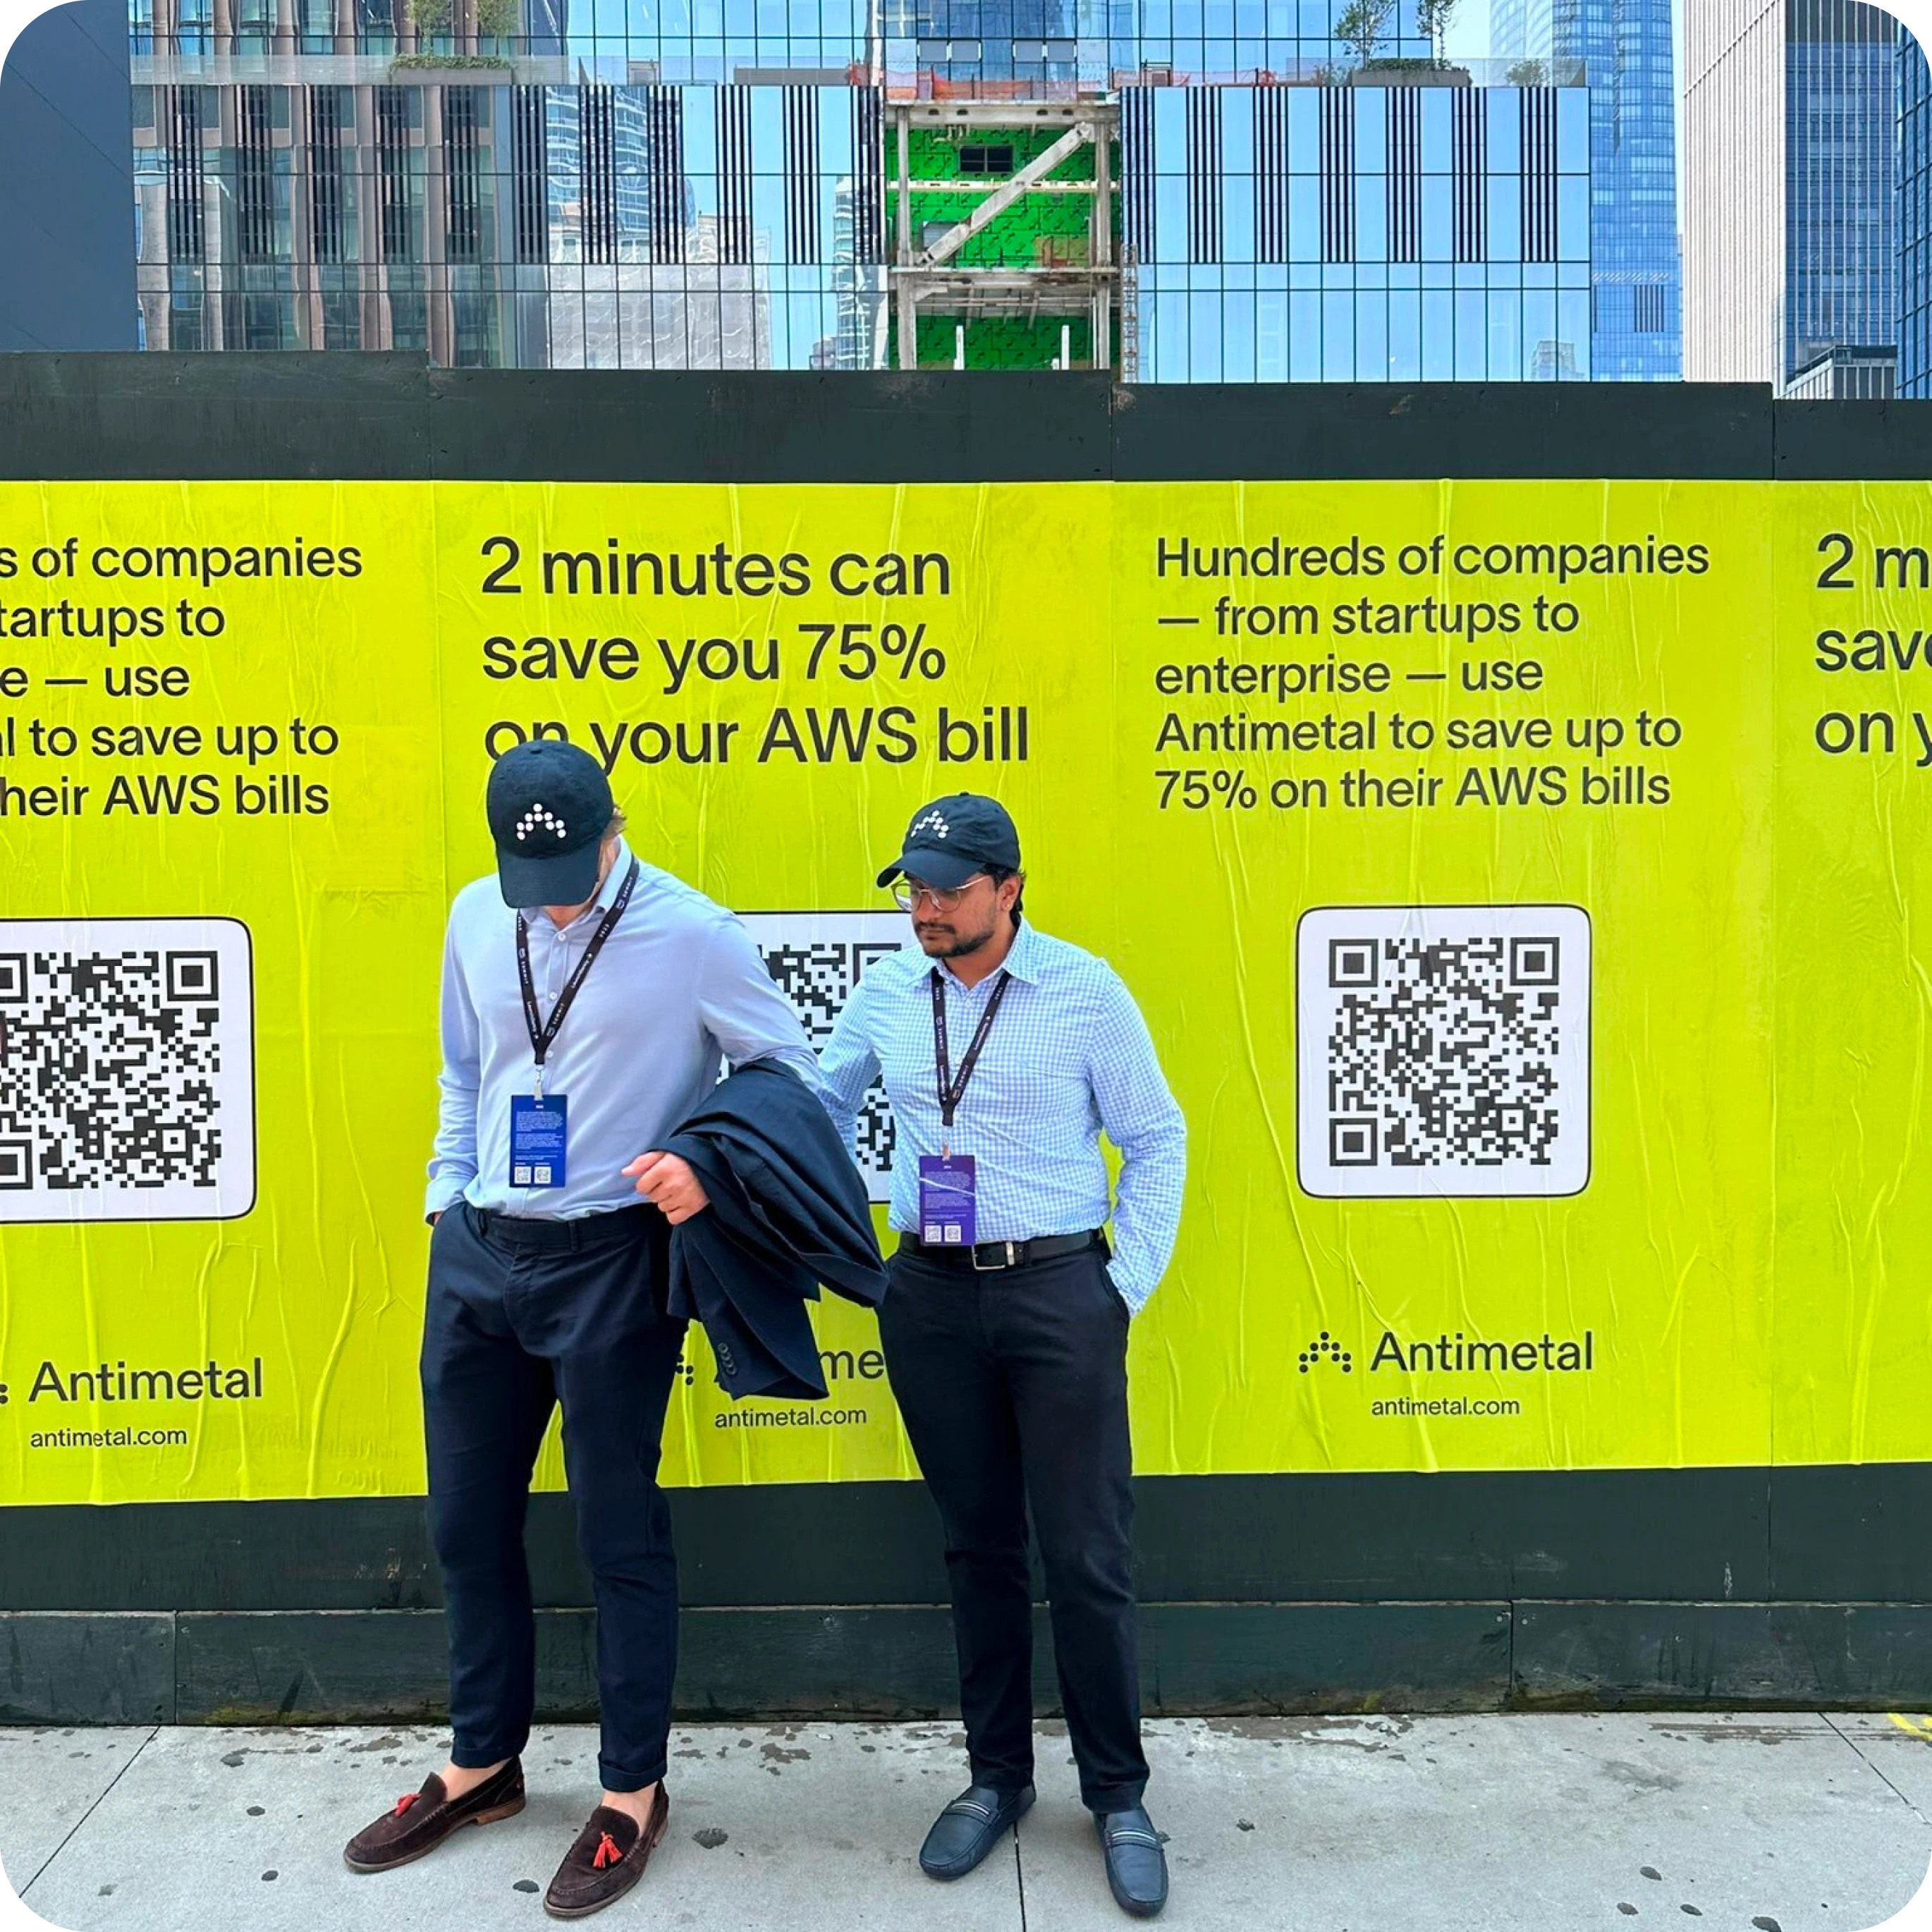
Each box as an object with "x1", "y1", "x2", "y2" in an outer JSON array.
[{"x1": 819, "y1": 794, "x2": 1186, "y2": 1916}]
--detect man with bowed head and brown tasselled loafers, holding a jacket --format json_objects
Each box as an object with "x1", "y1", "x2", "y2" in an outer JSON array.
[{"x1": 346, "y1": 742, "x2": 817, "y2": 1916}]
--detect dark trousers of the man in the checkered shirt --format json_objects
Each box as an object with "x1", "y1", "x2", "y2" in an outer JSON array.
[{"x1": 879, "y1": 1246, "x2": 1148, "y2": 1812}]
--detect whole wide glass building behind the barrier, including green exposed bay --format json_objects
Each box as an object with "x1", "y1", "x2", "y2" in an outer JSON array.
[{"x1": 113, "y1": 0, "x2": 1596, "y2": 381}]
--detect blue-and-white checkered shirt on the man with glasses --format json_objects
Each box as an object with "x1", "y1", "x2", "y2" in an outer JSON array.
[{"x1": 819, "y1": 924, "x2": 1188, "y2": 1310}]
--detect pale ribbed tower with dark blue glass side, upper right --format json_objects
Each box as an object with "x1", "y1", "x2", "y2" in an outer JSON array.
[{"x1": 1685, "y1": 0, "x2": 1899, "y2": 396}]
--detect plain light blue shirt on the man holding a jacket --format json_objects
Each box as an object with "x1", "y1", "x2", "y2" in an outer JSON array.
[{"x1": 423, "y1": 840, "x2": 823, "y2": 1221}]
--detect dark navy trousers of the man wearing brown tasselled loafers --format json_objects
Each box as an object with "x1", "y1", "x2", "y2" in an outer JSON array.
[{"x1": 423, "y1": 1204, "x2": 684, "y2": 1791}]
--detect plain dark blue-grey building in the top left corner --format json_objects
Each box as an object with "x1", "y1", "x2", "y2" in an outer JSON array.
[{"x1": 0, "y1": 0, "x2": 139, "y2": 352}]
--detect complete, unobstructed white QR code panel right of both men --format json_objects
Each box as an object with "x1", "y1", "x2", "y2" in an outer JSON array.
[{"x1": 1295, "y1": 906, "x2": 1590, "y2": 1198}]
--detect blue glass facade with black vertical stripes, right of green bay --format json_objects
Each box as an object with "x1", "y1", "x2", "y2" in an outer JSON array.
[{"x1": 1120, "y1": 70, "x2": 1592, "y2": 383}]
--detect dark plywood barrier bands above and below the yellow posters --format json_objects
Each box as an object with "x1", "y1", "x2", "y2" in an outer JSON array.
[{"x1": 0, "y1": 355, "x2": 1932, "y2": 1723}]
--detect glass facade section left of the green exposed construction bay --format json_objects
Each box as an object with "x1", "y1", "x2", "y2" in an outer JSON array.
[{"x1": 135, "y1": 0, "x2": 879, "y2": 369}]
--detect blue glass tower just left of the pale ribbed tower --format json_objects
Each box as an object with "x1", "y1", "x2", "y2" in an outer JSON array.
[{"x1": 1490, "y1": 0, "x2": 1683, "y2": 383}]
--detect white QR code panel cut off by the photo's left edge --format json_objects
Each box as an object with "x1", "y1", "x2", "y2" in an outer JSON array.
[{"x1": 0, "y1": 919, "x2": 255, "y2": 1221}]
